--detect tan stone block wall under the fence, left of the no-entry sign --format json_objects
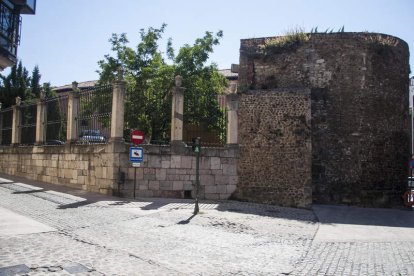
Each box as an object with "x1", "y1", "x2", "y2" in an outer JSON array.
[{"x1": 0, "y1": 144, "x2": 119, "y2": 194}]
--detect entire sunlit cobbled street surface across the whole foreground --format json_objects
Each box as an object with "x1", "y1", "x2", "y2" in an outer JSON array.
[{"x1": 0, "y1": 174, "x2": 414, "y2": 276}]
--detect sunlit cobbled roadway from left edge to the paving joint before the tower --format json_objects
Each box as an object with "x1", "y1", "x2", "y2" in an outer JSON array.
[{"x1": 0, "y1": 174, "x2": 318, "y2": 275}]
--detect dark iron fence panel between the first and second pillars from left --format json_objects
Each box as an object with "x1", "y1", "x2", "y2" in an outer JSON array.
[{"x1": 19, "y1": 103, "x2": 37, "y2": 145}]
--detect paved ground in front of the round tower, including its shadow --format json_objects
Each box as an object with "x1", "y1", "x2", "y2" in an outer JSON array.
[{"x1": 292, "y1": 205, "x2": 414, "y2": 276}]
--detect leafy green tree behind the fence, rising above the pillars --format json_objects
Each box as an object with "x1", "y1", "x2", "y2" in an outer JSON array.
[{"x1": 98, "y1": 24, "x2": 227, "y2": 143}]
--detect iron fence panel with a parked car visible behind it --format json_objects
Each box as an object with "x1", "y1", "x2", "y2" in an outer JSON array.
[{"x1": 77, "y1": 85, "x2": 112, "y2": 144}]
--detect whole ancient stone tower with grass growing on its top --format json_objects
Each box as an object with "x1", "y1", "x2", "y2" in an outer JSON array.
[{"x1": 235, "y1": 33, "x2": 410, "y2": 207}]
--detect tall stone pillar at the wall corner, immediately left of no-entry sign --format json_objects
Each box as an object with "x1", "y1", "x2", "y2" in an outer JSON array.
[{"x1": 109, "y1": 75, "x2": 126, "y2": 142}]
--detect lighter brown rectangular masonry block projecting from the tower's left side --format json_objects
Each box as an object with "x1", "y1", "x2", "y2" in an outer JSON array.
[{"x1": 234, "y1": 89, "x2": 312, "y2": 208}]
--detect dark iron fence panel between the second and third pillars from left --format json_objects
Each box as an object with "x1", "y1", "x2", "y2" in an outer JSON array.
[{"x1": 45, "y1": 95, "x2": 68, "y2": 145}]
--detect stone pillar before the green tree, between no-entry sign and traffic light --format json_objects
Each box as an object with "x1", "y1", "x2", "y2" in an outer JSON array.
[{"x1": 171, "y1": 76, "x2": 184, "y2": 143}]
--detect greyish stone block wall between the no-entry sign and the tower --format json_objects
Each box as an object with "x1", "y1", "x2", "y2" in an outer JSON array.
[{"x1": 121, "y1": 145, "x2": 238, "y2": 199}]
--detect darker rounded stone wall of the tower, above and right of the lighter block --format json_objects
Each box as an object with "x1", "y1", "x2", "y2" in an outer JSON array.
[{"x1": 239, "y1": 33, "x2": 410, "y2": 206}]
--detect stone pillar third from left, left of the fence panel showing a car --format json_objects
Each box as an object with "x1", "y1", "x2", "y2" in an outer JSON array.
[{"x1": 66, "y1": 81, "x2": 79, "y2": 143}]
